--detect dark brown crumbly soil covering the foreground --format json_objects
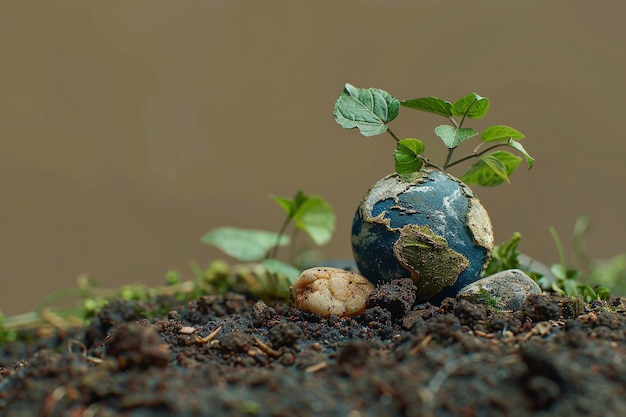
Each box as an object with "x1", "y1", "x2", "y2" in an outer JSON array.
[{"x1": 0, "y1": 282, "x2": 626, "y2": 417}]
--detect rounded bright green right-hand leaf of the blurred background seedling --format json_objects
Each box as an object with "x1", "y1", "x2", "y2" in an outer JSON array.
[{"x1": 294, "y1": 196, "x2": 335, "y2": 245}]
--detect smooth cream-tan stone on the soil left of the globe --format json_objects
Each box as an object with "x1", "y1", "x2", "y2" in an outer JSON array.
[{"x1": 290, "y1": 267, "x2": 374, "y2": 317}]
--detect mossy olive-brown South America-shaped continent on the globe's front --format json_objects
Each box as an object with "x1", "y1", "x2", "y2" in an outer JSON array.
[{"x1": 393, "y1": 224, "x2": 469, "y2": 302}]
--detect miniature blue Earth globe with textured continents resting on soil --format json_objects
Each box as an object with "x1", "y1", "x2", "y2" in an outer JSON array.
[{"x1": 352, "y1": 170, "x2": 493, "y2": 302}]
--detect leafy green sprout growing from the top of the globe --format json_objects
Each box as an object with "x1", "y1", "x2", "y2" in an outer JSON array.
[{"x1": 333, "y1": 84, "x2": 534, "y2": 186}]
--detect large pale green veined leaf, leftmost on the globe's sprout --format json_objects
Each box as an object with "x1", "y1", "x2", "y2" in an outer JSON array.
[{"x1": 333, "y1": 84, "x2": 400, "y2": 136}]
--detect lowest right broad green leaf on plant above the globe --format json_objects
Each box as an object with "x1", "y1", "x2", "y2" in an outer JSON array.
[{"x1": 459, "y1": 151, "x2": 522, "y2": 187}]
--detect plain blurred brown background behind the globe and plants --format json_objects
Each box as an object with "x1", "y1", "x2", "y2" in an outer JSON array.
[{"x1": 0, "y1": 0, "x2": 626, "y2": 314}]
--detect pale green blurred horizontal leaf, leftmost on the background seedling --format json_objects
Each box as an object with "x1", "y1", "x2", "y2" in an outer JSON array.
[{"x1": 201, "y1": 226, "x2": 290, "y2": 262}]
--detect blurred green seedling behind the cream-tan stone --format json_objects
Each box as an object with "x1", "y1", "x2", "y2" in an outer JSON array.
[{"x1": 202, "y1": 190, "x2": 335, "y2": 298}]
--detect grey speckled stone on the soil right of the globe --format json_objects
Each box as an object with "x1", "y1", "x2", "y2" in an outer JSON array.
[{"x1": 457, "y1": 269, "x2": 541, "y2": 311}]
